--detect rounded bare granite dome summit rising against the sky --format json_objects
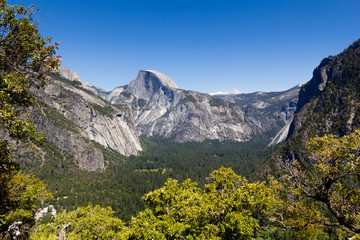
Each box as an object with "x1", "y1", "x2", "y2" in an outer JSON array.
[{"x1": 128, "y1": 70, "x2": 178, "y2": 100}]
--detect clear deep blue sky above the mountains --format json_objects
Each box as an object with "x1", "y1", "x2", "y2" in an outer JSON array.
[{"x1": 9, "y1": 0, "x2": 360, "y2": 93}]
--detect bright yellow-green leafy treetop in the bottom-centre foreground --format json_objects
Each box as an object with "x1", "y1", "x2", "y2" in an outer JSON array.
[{"x1": 129, "y1": 168, "x2": 274, "y2": 239}]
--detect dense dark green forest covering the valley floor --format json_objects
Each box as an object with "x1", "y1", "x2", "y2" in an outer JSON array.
[{"x1": 22, "y1": 137, "x2": 274, "y2": 220}]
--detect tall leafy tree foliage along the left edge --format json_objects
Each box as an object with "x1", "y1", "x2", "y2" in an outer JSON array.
[{"x1": 0, "y1": 0, "x2": 60, "y2": 237}]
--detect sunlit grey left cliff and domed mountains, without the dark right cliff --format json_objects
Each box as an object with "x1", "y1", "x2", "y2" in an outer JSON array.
[{"x1": 20, "y1": 67, "x2": 299, "y2": 171}]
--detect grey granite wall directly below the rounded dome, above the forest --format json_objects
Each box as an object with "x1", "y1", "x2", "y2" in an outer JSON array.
[{"x1": 136, "y1": 90, "x2": 257, "y2": 142}]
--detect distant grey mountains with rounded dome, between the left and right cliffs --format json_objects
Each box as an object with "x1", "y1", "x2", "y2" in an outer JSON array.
[{"x1": 71, "y1": 70, "x2": 300, "y2": 143}]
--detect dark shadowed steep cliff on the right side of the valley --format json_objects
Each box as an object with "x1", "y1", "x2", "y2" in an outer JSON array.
[{"x1": 282, "y1": 40, "x2": 360, "y2": 163}]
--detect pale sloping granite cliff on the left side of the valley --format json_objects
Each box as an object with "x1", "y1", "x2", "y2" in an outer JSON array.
[{"x1": 23, "y1": 68, "x2": 141, "y2": 171}]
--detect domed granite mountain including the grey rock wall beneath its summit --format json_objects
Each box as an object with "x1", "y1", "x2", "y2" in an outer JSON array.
[{"x1": 106, "y1": 70, "x2": 296, "y2": 142}]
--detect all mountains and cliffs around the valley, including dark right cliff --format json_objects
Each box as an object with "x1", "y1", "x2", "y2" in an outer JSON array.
[{"x1": 15, "y1": 38, "x2": 360, "y2": 171}]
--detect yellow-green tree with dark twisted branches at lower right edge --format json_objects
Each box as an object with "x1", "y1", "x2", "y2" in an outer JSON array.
[{"x1": 275, "y1": 130, "x2": 360, "y2": 239}]
